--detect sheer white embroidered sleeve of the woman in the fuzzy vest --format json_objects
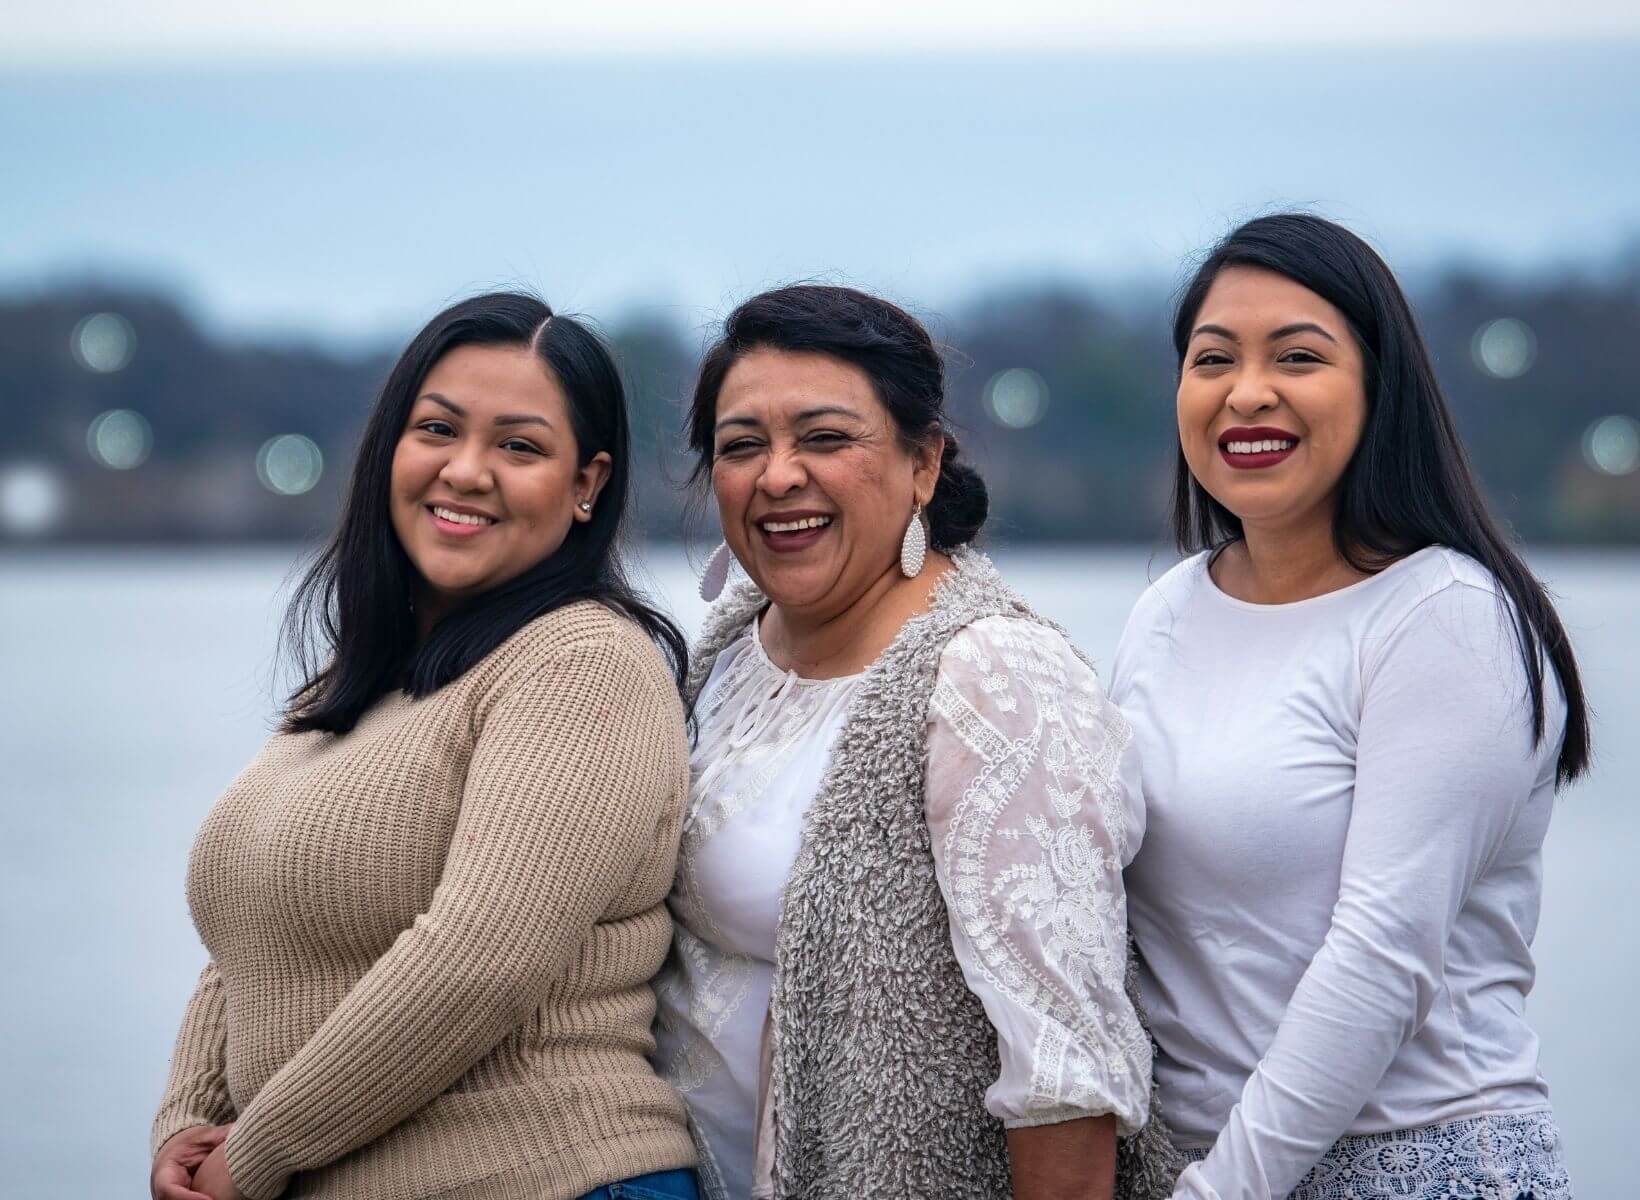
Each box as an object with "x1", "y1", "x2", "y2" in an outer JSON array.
[{"x1": 927, "y1": 616, "x2": 1150, "y2": 1134}]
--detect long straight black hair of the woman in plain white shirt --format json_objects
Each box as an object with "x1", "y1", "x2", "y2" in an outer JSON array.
[{"x1": 1173, "y1": 213, "x2": 1589, "y2": 784}]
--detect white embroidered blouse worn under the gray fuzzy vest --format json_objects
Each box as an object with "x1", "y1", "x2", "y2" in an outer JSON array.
[{"x1": 656, "y1": 616, "x2": 1150, "y2": 1197}]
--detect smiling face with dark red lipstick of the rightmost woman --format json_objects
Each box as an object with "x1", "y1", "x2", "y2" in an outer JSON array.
[{"x1": 1178, "y1": 267, "x2": 1366, "y2": 528}]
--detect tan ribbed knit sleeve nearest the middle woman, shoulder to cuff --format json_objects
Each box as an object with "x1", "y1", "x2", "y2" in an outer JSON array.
[{"x1": 226, "y1": 639, "x2": 682, "y2": 1200}]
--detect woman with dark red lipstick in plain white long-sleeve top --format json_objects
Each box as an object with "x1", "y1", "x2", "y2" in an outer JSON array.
[{"x1": 1112, "y1": 215, "x2": 1589, "y2": 1200}]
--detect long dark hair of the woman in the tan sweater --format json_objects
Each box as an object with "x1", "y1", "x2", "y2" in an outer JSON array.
[{"x1": 284, "y1": 292, "x2": 687, "y2": 733}]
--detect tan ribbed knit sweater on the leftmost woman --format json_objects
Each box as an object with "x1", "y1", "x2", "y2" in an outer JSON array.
[{"x1": 153, "y1": 603, "x2": 695, "y2": 1200}]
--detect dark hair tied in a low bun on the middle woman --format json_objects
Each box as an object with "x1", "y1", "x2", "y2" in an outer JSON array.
[{"x1": 689, "y1": 284, "x2": 991, "y2": 549}]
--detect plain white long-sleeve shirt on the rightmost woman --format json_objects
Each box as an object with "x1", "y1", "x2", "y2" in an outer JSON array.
[{"x1": 1112, "y1": 548, "x2": 1565, "y2": 1200}]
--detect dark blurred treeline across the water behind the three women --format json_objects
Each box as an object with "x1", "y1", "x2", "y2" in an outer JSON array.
[{"x1": 9, "y1": 256, "x2": 1640, "y2": 543}]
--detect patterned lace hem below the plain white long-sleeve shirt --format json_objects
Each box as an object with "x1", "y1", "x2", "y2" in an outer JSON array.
[{"x1": 1184, "y1": 1110, "x2": 1571, "y2": 1200}]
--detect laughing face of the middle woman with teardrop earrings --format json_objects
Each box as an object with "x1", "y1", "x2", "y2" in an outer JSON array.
[{"x1": 712, "y1": 349, "x2": 940, "y2": 616}]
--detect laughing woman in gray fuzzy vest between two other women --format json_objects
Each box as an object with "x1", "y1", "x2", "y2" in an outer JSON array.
[{"x1": 658, "y1": 285, "x2": 1179, "y2": 1200}]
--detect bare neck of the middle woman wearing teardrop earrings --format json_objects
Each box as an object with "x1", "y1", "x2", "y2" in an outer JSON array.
[{"x1": 763, "y1": 552, "x2": 951, "y2": 679}]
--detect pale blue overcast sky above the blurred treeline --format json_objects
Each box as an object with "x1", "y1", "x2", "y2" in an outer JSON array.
[{"x1": 0, "y1": 12, "x2": 1640, "y2": 343}]
